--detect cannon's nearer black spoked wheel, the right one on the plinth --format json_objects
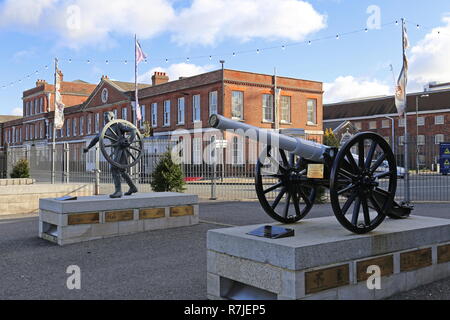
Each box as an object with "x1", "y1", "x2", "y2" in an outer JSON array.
[{"x1": 330, "y1": 132, "x2": 397, "y2": 234}]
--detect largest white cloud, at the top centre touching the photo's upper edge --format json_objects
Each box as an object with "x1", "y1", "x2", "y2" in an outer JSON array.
[{"x1": 172, "y1": 0, "x2": 326, "y2": 45}]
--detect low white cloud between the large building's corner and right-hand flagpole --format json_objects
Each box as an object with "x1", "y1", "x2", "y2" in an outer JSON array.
[{"x1": 324, "y1": 76, "x2": 392, "y2": 103}]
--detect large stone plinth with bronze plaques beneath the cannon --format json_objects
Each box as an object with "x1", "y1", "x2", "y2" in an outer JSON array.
[{"x1": 207, "y1": 216, "x2": 450, "y2": 300}]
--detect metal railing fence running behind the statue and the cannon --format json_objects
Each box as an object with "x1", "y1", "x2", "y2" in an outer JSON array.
[{"x1": 0, "y1": 137, "x2": 450, "y2": 201}]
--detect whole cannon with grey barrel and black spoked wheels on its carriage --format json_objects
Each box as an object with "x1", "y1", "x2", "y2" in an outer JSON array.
[{"x1": 209, "y1": 114, "x2": 412, "y2": 234}]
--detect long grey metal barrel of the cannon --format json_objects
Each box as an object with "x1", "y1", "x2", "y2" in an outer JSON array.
[{"x1": 209, "y1": 114, "x2": 330, "y2": 162}]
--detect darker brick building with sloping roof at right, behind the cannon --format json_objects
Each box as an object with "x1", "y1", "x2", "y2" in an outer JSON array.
[{"x1": 324, "y1": 88, "x2": 450, "y2": 168}]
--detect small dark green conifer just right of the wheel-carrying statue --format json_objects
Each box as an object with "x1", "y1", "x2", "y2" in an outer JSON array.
[{"x1": 150, "y1": 151, "x2": 186, "y2": 192}]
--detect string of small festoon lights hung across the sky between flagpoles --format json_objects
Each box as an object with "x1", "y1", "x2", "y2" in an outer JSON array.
[{"x1": 0, "y1": 20, "x2": 445, "y2": 89}]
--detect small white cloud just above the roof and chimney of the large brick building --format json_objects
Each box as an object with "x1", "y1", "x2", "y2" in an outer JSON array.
[{"x1": 138, "y1": 63, "x2": 214, "y2": 83}]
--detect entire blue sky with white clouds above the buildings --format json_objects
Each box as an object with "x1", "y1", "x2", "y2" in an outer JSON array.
[{"x1": 0, "y1": 0, "x2": 450, "y2": 115}]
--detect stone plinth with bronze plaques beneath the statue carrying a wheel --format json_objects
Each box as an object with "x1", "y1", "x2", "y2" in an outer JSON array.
[{"x1": 39, "y1": 192, "x2": 199, "y2": 245}]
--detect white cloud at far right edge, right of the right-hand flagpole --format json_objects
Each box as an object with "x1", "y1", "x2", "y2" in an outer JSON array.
[{"x1": 409, "y1": 15, "x2": 450, "y2": 88}]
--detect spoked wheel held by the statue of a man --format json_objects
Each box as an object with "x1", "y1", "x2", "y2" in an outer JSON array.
[{"x1": 99, "y1": 119, "x2": 144, "y2": 169}]
